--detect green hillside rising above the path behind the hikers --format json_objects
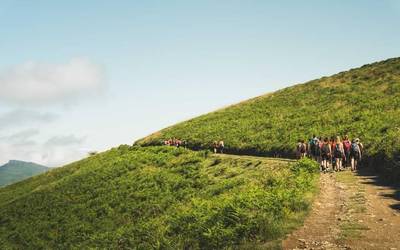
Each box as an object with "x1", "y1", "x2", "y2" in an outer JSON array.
[{"x1": 137, "y1": 58, "x2": 400, "y2": 178}]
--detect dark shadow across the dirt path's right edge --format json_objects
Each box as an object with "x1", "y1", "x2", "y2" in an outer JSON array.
[{"x1": 357, "y1": 168, "x2": 400, "y2": 212}]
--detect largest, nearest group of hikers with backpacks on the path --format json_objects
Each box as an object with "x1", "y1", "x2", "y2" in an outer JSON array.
[{"x1": 296, "y1": 135, "x2": 364, "y2": 173}]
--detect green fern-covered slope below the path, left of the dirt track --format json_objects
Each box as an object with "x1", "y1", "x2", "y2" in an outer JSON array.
[{"x1": 0, "y1": 146, "x2": 317, "y2": 249}]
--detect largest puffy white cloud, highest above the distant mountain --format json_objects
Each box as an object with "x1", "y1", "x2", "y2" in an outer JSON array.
[{"x1": 0, "y1": 58, "x2": 105, "y2": 104}]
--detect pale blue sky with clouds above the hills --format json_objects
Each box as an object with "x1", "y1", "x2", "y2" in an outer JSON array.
[{"x1": 0, "y1": 0, "x2": 400, "y2": 167}]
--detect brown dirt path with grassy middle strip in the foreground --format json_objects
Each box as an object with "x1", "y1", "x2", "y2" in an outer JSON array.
[{"x1": 283, "y1": 171, "x2": 400, "y2": 250}]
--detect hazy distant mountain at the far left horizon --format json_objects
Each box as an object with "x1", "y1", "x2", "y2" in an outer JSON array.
[{"x1": 0, "y1": 160, "x2": 48, "y2": 187}]
